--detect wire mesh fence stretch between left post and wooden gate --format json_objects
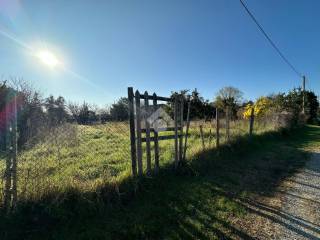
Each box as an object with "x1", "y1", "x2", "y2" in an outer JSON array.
[{"x1": 17, "y1": 122, "x2": 130, "y2": 200}]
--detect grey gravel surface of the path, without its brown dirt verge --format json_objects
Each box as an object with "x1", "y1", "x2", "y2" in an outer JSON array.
[{"x1": 278, "y1": 153, "x2": 320, "y2": 239}]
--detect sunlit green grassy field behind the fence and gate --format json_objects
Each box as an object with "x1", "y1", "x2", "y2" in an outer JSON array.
[{"x1": 0, "y1": 117, "x2": 274, "y2": 201}]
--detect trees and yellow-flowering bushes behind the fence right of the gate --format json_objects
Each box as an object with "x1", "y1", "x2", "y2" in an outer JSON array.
[{"x1": 167, "y1": 86, "x2": 320, "y2": 124}]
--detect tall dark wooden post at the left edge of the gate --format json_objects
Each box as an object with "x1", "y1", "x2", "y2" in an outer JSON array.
[{"x1": 128, "y1": 87, "x2": 137, "y2": 176}]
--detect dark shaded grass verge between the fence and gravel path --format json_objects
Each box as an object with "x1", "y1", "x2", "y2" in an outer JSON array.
[{"x1": 0, "y1": 126, "x2": 320, "y2": 239}]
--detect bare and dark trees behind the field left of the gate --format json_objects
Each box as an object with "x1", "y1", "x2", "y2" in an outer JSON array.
[{"x1": 0, "y1": 79, "x2": 128, "y2": 150}]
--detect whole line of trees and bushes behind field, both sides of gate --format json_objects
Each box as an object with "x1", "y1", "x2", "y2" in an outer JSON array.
[{"x1": 0, "y1": 80, "x2": 319, "y2": 148}]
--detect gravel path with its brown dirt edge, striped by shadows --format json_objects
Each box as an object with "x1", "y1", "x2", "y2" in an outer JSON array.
[{"x1": 233, "y1": 151, "x2": 320, "y2": 240}]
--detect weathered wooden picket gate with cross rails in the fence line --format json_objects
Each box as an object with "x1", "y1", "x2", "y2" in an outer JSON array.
[{"x1": 128, "y1": 87, "x2": 190, "y2": 176}]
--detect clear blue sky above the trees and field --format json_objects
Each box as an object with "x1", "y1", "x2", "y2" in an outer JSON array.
[{"x1": 0, "y1": 0, "x2": 320, "y2": 105}]
